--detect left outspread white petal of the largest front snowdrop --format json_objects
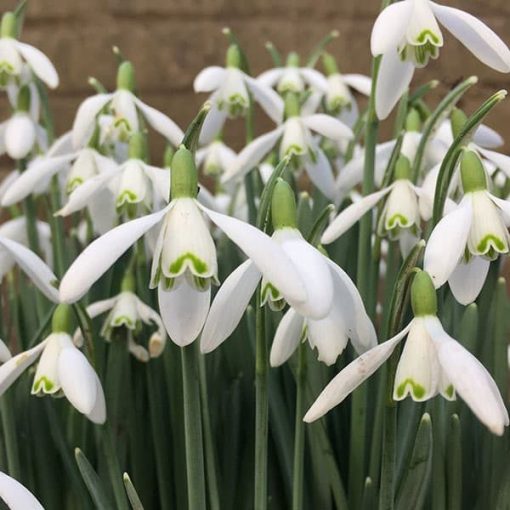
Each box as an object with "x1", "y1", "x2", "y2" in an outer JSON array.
[{"x1": 60, "y1": 207, "x2": 168, "y2": 303}]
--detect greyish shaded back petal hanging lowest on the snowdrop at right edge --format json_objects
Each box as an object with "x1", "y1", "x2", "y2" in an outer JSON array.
[{"x1": 448, "y1": 256, "x2": 490, "y2": 305}]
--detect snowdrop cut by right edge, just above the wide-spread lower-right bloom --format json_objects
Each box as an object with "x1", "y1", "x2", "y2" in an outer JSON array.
[{"x1": 424, "y1": 150, "x2": 510, "y2": 304}]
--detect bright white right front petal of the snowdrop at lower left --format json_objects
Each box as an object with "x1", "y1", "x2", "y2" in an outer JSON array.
[{"x1": 58, "y1": 346, "x2": 97, "y2": 414}]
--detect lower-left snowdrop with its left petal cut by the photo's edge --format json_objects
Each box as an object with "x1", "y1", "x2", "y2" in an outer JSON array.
[{"x1": 0, "y1": 305, "x2": 106, "y2": 424}]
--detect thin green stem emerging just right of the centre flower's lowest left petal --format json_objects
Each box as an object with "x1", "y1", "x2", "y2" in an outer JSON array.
[{"x1": 292, "y1": 343, "x2": 306, "y2": 510}]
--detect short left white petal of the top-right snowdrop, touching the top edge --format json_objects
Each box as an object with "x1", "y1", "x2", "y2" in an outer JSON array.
[{"x1": 370, "y1": 1, "x2": 413, "y2": 57}]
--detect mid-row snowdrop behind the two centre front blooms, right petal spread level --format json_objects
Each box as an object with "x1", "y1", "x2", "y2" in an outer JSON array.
[{"x1": 222, "y1": 93, "x2": 353, "y2": 199}]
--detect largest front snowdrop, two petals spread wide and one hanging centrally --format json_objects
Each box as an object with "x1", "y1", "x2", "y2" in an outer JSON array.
[{"x1": 60, "y1": 147, "x2": 307, "y2": 346}]
